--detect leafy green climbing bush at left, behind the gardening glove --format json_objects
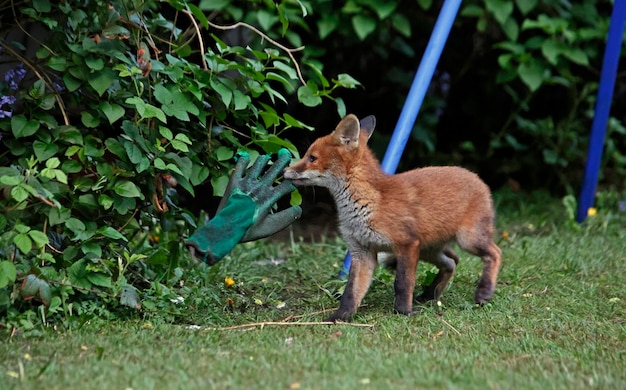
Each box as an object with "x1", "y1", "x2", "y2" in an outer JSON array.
[{"x1": 0, "y1": 0, "x2": 358, "y2": 328}]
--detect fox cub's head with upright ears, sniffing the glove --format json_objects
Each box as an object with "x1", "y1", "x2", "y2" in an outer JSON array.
[{"x1": 285, "y1": 114, "x2": 376, "y2": 187}]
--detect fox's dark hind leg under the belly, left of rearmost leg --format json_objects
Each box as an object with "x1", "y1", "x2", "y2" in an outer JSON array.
[{"x1": 415, "y1": 245, "x2": 459, "y2": 303}]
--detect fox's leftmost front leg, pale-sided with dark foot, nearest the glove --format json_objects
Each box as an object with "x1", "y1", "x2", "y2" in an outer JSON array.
[{"x1": 327, "y1": 250, "x2": 377, "y2": 322}]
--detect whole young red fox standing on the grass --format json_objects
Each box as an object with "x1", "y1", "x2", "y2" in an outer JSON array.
[{"x1": 284, "y1": 114, "x2": 502, "y2": 321}]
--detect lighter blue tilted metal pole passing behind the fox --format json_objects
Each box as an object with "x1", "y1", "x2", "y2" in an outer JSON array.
[{"x1": 339, "y1": 0, "x2": 462, "y2": 277}]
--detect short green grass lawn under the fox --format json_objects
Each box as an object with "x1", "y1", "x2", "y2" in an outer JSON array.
[{"x1": 0, "y1": 196, "x2": 626, "y2": 390}]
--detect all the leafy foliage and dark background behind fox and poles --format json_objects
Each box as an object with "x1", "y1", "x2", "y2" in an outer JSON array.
[{"x1": 0, "y1": 0, "x2": 626, "y2": 327}]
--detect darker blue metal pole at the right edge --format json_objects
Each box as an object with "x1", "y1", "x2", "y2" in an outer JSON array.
[{"x1": 576, "y1": 0, "x2": 626, "y2": 222}]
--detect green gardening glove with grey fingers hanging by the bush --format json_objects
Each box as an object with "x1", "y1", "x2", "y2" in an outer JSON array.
[{"x1": 186, "y1": 149, "x2": 302, "y2": 265}]
